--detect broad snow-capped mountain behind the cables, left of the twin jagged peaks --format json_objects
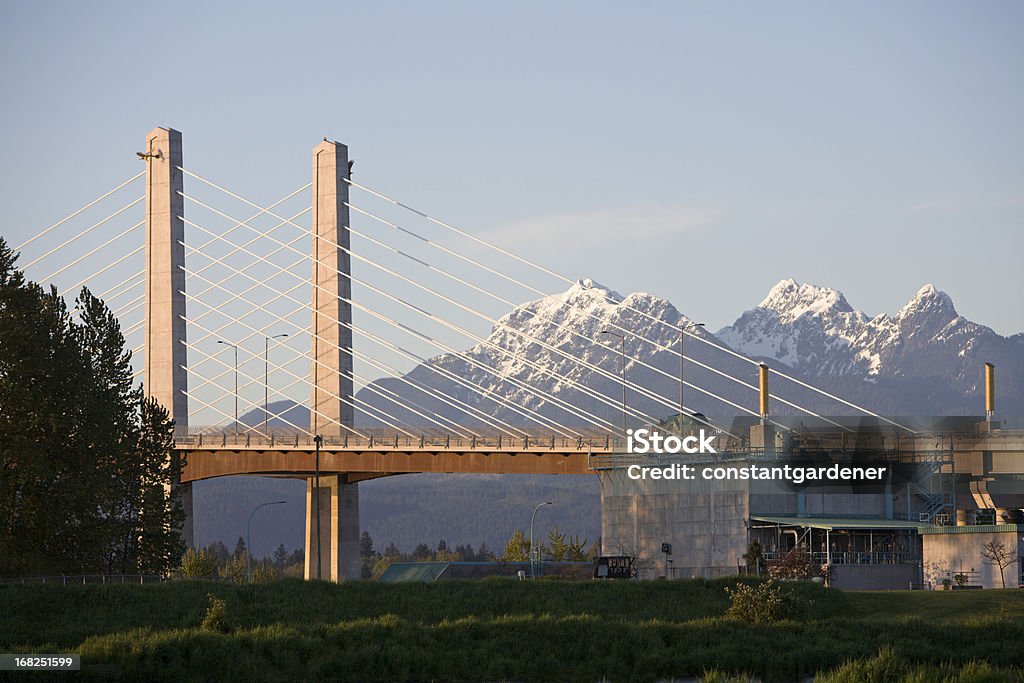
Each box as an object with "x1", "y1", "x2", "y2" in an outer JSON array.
[{"x1": 356, "y1": 280, "x2": 752, "y2": 427}]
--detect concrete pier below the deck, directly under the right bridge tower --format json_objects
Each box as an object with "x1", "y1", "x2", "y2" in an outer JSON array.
[{"x1": 305, "y1": 476, "x2": 359, "y2": 582}]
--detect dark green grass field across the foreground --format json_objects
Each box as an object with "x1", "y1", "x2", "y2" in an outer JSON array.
[{"x1": 0, "y1": 580, "x2": 1024, "y2": 682}]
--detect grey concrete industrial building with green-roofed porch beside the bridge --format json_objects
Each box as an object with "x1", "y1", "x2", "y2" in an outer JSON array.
[{"x1": 591, "y1": 411, "x2": 1024, "y2": 590}]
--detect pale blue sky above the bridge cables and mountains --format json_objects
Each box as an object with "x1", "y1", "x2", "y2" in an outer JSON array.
[{"x1": 0, "y1": 1, "x2": 1024, "y2": 334}]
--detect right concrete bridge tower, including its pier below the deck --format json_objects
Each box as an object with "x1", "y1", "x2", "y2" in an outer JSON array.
[{"x1": 305, "y1": 138, "x2": 359, "y2": 581}]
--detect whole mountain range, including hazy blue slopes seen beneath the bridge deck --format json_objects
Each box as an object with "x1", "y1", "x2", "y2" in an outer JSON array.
[{"x1": 196, "y1": 280, "x2": 1024, "y2": 554}]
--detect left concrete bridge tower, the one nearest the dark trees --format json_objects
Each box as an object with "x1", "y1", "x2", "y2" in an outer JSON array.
[{"x1": 143, "y1": 128, "x2": 194, "y2": 547}]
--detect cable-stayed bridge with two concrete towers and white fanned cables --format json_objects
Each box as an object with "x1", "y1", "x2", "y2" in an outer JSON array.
[{"x1": 16, "y1": 128, "x2": 1007, "y2": 579}]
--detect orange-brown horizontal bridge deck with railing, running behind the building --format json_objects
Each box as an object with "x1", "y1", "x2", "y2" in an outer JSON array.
[{"x1": 175, "y1": 431, "x2": 1024, "y2": 481}]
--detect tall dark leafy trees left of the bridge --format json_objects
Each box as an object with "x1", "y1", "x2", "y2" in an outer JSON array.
[{"x1": 0, "y1": 238, "x2": 183, "y2": 577}]
